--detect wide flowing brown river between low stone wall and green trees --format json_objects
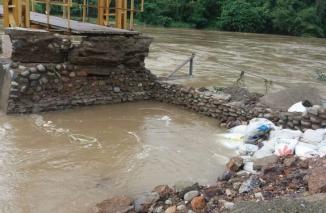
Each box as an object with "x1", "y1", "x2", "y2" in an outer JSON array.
[{"x1": 140, "y1": 28, "x2": 326, "y2": 97}]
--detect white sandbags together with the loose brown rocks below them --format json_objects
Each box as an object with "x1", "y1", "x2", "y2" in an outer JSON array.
[{"x1": 93, "y1": 118, "x2": 326, "y2": 213}]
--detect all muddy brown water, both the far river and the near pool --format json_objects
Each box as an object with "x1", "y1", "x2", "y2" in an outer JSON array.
[{"x1": 0, "y1": 22, "x2": 326, "y2": 213}]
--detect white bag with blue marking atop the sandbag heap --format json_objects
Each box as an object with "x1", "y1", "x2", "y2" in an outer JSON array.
[{"x1": 244, "y1": 118, "x2": 275, "y2": 144}]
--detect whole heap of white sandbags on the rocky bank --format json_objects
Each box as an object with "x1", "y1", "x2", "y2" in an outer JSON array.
[{"x1": 219, "y1": 118, "x2": 326, "y2": 162}]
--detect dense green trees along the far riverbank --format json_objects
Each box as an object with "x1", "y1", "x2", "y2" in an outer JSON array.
[{"x1": 137, "y1": 0, "x2": 326, "y2": 37}]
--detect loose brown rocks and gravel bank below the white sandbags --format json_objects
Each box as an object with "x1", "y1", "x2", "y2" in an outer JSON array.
[{"x1": 91, "y1": 156, "x2": 326, "y2": 213}]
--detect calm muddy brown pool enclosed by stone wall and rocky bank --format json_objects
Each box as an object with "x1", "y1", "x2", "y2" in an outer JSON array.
[{"x1": 0, "y1": 102, "x2": 232, "y2": 213}]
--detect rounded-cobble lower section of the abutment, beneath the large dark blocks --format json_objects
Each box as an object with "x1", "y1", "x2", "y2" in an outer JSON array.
[{"x1": 7, "y1": 64, "x2": 155, "y2": 113}]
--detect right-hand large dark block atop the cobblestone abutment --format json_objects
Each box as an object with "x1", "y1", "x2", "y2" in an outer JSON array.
[{"x1": 69, "y1": 35, "x2": 152, "y2": 66}]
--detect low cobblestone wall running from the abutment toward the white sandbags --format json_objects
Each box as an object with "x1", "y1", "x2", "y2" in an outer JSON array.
[{"x1": 152, "y1": 82, "x2": 326, "y2": 131}]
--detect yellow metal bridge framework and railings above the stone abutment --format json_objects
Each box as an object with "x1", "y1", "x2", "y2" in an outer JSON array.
[{"x1": 3, "y1": 0, "x2": 144, "y2": 30}]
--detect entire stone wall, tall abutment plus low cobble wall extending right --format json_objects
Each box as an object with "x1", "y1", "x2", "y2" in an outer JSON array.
[{"x1": 0, "y1": 29, "x2": 326, "y2": 130}]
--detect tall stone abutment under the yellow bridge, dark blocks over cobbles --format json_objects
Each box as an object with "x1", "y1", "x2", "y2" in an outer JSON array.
[{"x1": 1, "y1": 29, "x2": 156, "y2": 113}]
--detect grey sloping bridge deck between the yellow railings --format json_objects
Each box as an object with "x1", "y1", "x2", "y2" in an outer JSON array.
[{"x1": 0, "y1": 5, "x2": 139, "y2": 35}]
